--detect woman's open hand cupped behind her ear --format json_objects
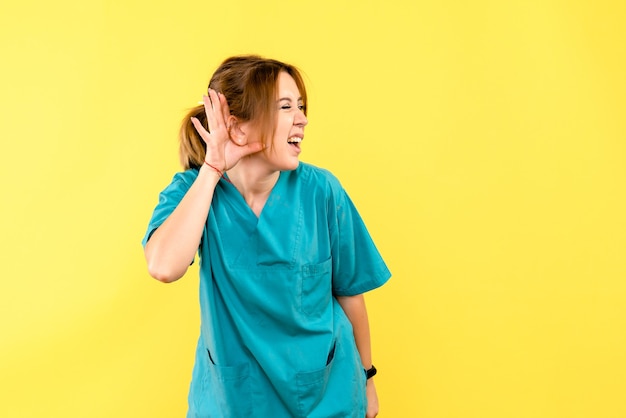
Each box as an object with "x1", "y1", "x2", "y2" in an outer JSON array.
[{"x1": 191, "y1": 89, "x2": 263, "y2": 172}]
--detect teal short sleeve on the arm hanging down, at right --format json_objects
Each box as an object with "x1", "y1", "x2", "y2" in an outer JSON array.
[{"x1": 329, "y1": 181, "x2": 391, "y2": 296}]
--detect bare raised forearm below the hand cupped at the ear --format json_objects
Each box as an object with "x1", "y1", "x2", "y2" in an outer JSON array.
[{"x1": 144, "y1": 166, "x2": 219, "y2": 282}]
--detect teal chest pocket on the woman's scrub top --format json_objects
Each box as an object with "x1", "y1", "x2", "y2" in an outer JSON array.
[{"x1": 299, "y1": 258, "x2": 333, "y2": 318}]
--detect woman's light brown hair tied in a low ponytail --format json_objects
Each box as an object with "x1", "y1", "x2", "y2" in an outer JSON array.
[{"x1": 179, "y1": 55, "x2": 307, "y2": 170}]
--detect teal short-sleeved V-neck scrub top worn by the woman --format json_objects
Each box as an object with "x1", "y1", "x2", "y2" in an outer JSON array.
[{"x1": 144, "y1": 163, "x2": 390, "y2": 418}]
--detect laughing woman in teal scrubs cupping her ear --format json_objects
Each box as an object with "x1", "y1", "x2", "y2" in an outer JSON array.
[{"x1": 143, "y1": 56, "x2": 390, "y2": 418}]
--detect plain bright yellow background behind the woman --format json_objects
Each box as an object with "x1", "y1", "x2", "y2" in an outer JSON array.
[{"x1": 0, "y1": 0, "x2": 626, "y2": 418}]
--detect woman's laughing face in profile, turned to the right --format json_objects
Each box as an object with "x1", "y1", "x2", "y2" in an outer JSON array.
[{"x1": 258, "y1": 72, "x2": 308, "y2": 170}]
